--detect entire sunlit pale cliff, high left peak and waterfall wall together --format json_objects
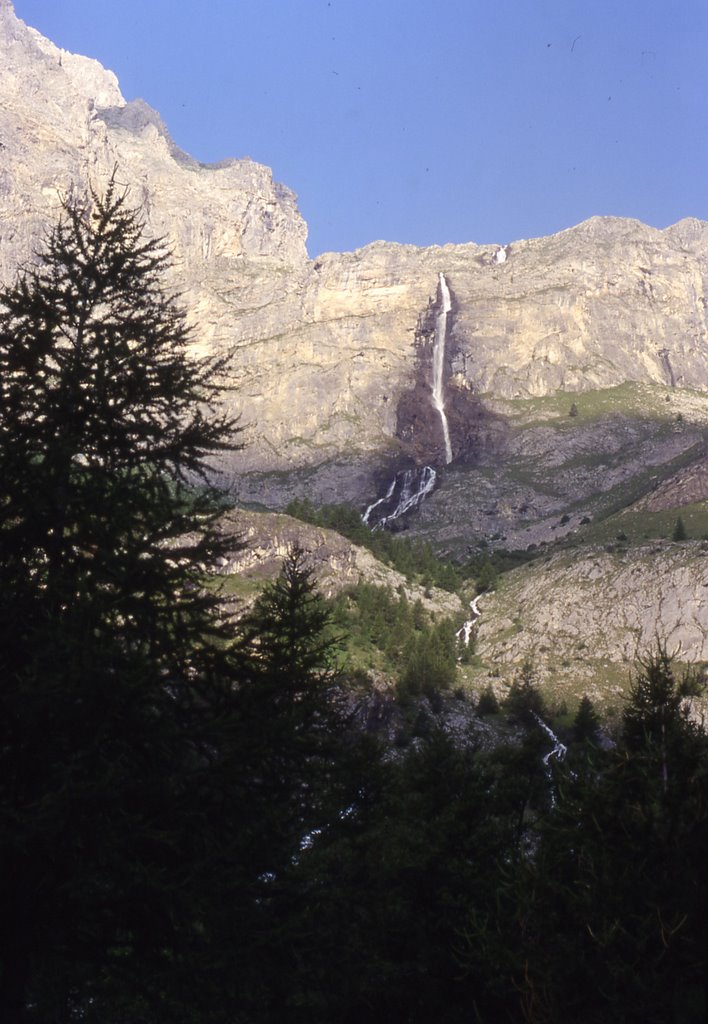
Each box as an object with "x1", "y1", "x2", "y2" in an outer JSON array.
[{"x1": 0, "y1": 0, "x2": 708, "y2": 504}]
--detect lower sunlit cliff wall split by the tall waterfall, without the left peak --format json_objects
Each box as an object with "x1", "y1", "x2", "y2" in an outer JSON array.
[{"x1": 200, "y1": 218, "x2": 708, "y2": 491}]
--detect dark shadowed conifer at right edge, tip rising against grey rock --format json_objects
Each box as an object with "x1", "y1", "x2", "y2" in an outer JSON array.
[{"x1": 518, "y1": 647, "x2": 708, "y2": 1024}]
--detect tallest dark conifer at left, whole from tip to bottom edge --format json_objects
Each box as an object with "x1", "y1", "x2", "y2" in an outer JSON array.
[{"x1": 0, "y1": 176, "x2": 242, "y2": 1024}]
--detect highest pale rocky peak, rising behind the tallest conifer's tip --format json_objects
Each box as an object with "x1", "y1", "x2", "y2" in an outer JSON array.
[{"x1": 0, "y1": 0, "x2": 306, "y2": 299}]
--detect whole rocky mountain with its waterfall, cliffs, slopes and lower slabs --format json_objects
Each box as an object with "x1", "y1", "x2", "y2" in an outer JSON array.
[{"x1": 0, "y1": 0, "x2": 708, "y2": 696}]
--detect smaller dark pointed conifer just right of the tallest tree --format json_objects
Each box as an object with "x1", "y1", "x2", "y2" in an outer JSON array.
[{"x1": 229, "y1": 547, "x2": 345, "y2": 872}]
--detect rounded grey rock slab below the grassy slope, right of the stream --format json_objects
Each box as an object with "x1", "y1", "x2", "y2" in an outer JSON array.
[{"x1": 478, "y1": 541, "x2": 708, "y2": 668}]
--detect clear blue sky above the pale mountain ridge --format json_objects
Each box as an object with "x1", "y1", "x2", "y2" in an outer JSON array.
[{"x1": 14, "y1": 0, "x2": 708, "y2": 256}]
